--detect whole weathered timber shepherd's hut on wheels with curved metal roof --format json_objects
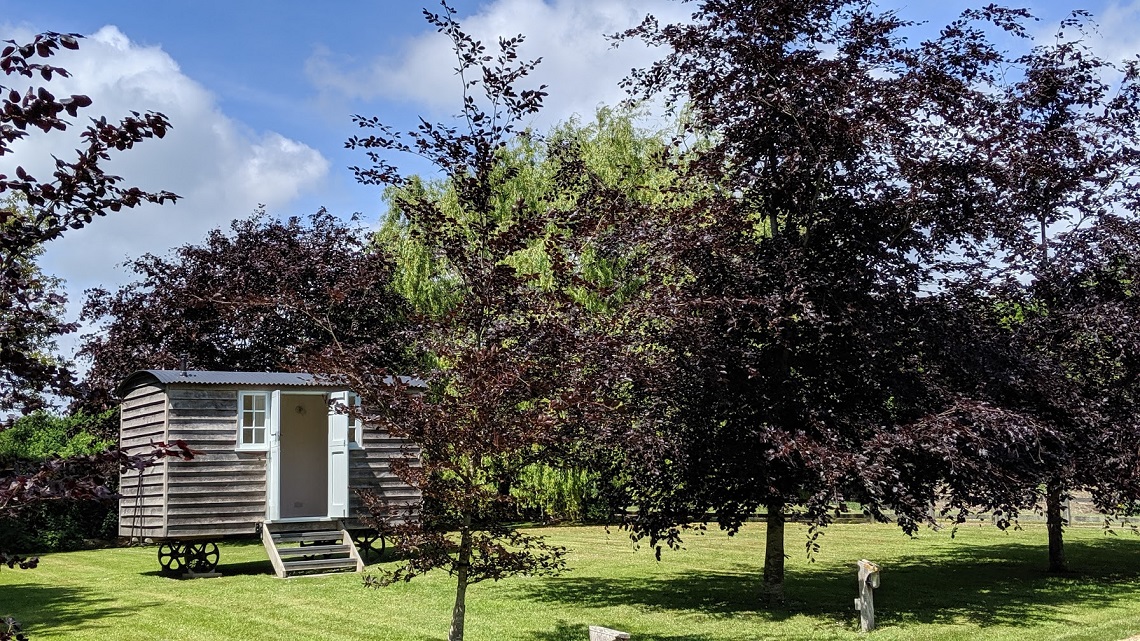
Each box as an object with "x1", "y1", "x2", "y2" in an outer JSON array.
[{"x1": 119, "y1": 370, "x2": 420, "y2": 577}]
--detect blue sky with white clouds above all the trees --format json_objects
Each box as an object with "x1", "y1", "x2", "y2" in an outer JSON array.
[{"x1": 0, "y1": 0, "x2": 1140, "y2": 360}]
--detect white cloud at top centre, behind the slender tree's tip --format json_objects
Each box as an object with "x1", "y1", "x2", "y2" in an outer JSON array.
[{"x1": 307, "y1": 0, "x2": 691, "y2": 127}]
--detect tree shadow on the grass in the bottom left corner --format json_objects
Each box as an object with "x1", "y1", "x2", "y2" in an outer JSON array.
[{"x1": 0, "y1": 584, "x2": 161, "y2": 639}]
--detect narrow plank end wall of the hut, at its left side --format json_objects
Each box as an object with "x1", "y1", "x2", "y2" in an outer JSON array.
[{"x1": 119, "y1": 386, "x2": 166, "y2": 538}]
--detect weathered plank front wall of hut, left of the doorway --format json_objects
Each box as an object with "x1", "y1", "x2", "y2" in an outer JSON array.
[{"x1": 166, "y1": 386, "x2": 266, "y2": 538}]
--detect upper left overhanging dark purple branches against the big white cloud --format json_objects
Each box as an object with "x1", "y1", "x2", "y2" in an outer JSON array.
[{"x1": 0, "y1": 32, "x2": 178, "y2": 409}]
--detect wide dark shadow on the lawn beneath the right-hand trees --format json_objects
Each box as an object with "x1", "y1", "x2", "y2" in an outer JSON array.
[{"x1": 520, "y1": 539, "x2": 1140, "y2": 629}]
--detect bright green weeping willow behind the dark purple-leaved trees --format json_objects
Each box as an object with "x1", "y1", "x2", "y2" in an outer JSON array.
[{"x1": 376, "y1": 107, "x2": 676, "y2": 519}]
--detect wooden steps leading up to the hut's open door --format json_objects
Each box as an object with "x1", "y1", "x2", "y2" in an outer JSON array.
[{"x1": 261, "y1": 521, "x2": 364, "y2": 578}]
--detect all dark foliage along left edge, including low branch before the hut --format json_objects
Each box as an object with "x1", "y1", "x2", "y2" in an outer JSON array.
[{"x1": 0, "y1": 32, "x2": 178, "y2": 639}]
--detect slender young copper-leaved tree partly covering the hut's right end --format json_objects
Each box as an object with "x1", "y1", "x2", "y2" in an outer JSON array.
[{"x1": 318, "y1": 5, "x2": 615, "y2": 641}]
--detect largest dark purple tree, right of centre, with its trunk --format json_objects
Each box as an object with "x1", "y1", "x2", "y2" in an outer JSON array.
[{"x1": 620, "y1": 0, "x2": 961, "y2": 599}]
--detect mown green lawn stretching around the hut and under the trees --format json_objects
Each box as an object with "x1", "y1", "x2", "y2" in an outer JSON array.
[{"x1": 0, "y1": 525, "x2": 1140, "y2": 641}]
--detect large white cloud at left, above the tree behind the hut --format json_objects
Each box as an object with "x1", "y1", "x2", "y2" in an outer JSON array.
[{"x1": 0, "y1": 26, "x2": 329, "y2": 294}]
